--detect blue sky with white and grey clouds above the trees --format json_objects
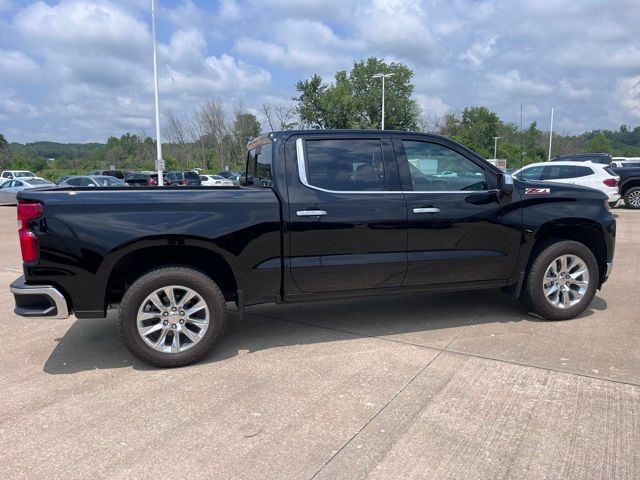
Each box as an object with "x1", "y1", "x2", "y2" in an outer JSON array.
[{"x1": 0, "y1": 0, "x2": 640, "y2": 142}]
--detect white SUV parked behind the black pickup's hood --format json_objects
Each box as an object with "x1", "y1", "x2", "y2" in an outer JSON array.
[{"x1": 513, "y1": 161, "x2": 620, "y2": 207}]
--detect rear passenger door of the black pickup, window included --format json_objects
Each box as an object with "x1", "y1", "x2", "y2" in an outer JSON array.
[{"x1": 284, "y1": 134, "x2": 407, "y2": 293}]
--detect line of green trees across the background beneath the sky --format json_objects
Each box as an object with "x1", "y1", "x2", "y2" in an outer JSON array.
[{"x1": 0, "y1": 57, "x2": 640, "y2": 179}]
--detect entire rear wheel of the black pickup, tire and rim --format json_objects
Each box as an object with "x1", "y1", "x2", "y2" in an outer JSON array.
[{"x1": 118, "y1": 267, "x2": 227, "y2": 367}]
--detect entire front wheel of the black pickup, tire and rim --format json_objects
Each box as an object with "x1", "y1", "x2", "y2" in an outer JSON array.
[{"x1": 521, "y1": 240, "x2": 599, "y2": 320}]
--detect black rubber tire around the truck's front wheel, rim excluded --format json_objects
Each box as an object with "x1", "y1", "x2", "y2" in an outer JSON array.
[{"x1": 520, "y1": 240, "x2": 599, "y2": 320}]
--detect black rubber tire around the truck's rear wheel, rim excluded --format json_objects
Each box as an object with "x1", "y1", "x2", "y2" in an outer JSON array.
[{"x1": 118, "y1": 267, "x2": 227, "y2": 368}]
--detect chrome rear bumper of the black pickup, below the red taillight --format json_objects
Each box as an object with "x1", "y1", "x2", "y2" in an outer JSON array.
[{"x1": 9, "y1": 277, "x2": 69, "y2": 319}]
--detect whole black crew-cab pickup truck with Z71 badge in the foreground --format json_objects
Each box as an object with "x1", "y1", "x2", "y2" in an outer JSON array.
[{"x1": 11, "y1": 131, "x2": 615, "y2": 367}]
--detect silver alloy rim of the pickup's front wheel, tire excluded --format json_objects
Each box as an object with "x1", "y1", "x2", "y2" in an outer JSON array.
[{"x1": 542, "y1": 255, "x2": 589, "y2": 309}]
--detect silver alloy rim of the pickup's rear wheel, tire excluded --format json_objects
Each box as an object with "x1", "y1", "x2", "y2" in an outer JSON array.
[{"x1": 136, "y1": 285, "x2": 210, "y2": 353}]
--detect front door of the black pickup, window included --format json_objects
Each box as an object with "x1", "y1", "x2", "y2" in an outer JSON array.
[{"x1": 395, "y1": 137, "x2": 522, "y2": 286}]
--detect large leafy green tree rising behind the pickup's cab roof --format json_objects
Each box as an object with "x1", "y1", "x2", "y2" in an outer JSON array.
[{"x1": 294, "y1": 57, "x2": 420, "y2": 130}]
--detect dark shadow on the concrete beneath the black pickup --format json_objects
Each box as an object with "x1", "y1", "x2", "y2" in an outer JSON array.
[{"x1": 43, "y1": 290, "x2": 607, "y2": 375}]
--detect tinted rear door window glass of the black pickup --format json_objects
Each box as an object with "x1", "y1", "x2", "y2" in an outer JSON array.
[{"x1": 306, "y1": 139, "x2": 386, "y2": 192}]
